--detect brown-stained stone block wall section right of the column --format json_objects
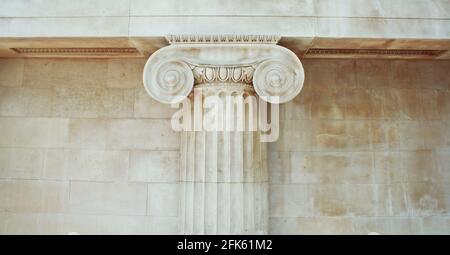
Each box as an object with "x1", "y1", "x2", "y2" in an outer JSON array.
[{"x1": 269, "y1": 60, "x2": 450, "y2": 234}]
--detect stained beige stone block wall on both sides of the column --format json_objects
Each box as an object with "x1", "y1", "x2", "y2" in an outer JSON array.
[{"x1": 0, "y1": 59, "x2": 450, "y2": 234}]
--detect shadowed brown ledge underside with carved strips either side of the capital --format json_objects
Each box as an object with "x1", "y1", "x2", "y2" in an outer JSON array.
[{"x1": 0, "y1": 36, "x2": 450, "y2": 59}]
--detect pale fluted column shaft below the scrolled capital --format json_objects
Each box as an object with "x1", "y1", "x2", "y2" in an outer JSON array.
[{"x1": 180, "y1": 83, "x2": 268, "y2": 234}]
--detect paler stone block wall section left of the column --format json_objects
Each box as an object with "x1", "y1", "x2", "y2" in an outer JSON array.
[{"x1": 0, "y1": 59, "x2": 179, "y2": 234}]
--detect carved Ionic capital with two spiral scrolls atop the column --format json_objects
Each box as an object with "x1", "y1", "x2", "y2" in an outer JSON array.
[{"x1": 144, "y1": 36, "x2": 305, "y2": 104}]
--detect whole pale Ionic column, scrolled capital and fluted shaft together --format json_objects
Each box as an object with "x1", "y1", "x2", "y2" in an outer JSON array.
[{"x1": 144, "y1": 36, "x2": 304, "y2": 234}]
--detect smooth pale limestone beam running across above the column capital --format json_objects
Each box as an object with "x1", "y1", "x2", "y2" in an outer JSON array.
[{"x1": 0, "y1": 0, "x2": 450, "y2": 39}]
